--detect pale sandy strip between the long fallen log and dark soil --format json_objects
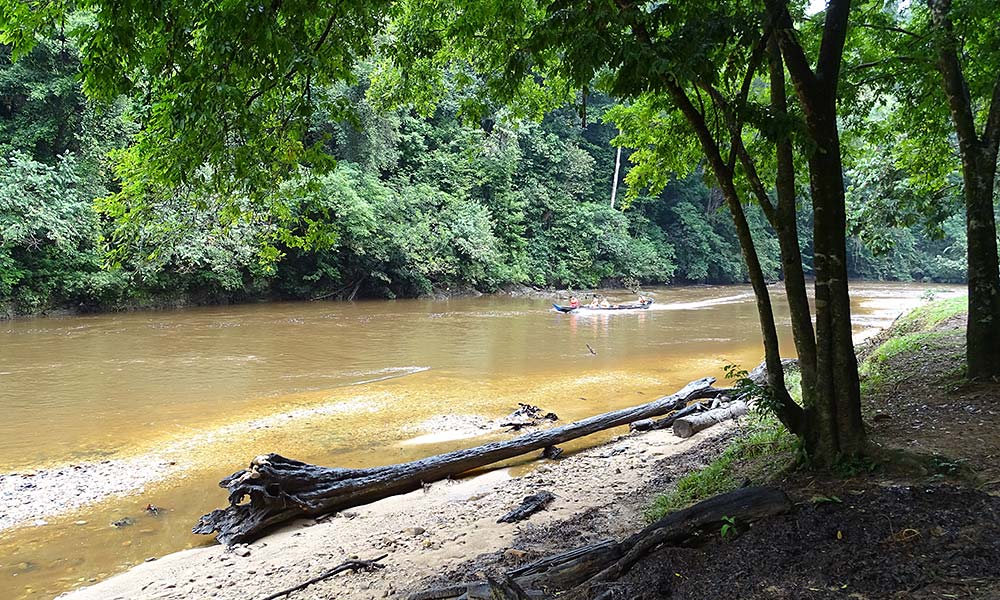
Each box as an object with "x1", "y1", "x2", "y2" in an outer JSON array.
[{"x1": 60, "y1": 423, "x2": 734, "y2": 600}]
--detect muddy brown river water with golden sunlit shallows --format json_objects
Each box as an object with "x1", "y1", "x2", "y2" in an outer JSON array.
[{"x1": 0, "y1": 283, "x2": 958, "y2": 599}]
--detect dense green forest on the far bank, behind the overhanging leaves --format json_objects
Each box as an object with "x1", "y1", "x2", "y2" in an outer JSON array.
[{"x1": 0, "y1": 28, "x2": 966, "y2": 315}]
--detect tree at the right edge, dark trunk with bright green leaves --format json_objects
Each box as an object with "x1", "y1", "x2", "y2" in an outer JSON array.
[{"x1": 857, "y1": 0, "x2": 1000, "y2": 378}]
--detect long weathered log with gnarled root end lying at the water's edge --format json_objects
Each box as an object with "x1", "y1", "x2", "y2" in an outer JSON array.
[{"x1": 192, "y1": 377, "x2": 715, "y2": 544}]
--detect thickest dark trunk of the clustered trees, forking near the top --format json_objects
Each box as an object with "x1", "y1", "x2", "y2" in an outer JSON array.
[{"x1": 767, "y1": 0, "x2": 866, "y2": 466}]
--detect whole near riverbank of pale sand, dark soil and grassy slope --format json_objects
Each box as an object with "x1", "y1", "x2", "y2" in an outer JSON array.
[{"x1": 62, "y1": 301, "x2": 1000, "y2": 600}]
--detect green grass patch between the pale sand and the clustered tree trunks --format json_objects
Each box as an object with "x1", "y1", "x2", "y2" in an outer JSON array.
[{"x1": 646, "y1": 412, "x2": 799, "y2": 521}]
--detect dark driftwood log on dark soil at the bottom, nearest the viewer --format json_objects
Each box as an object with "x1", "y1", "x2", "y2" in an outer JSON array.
[{"x1": 409, "y1": 487, "x2": 792, "y2": 600}]
